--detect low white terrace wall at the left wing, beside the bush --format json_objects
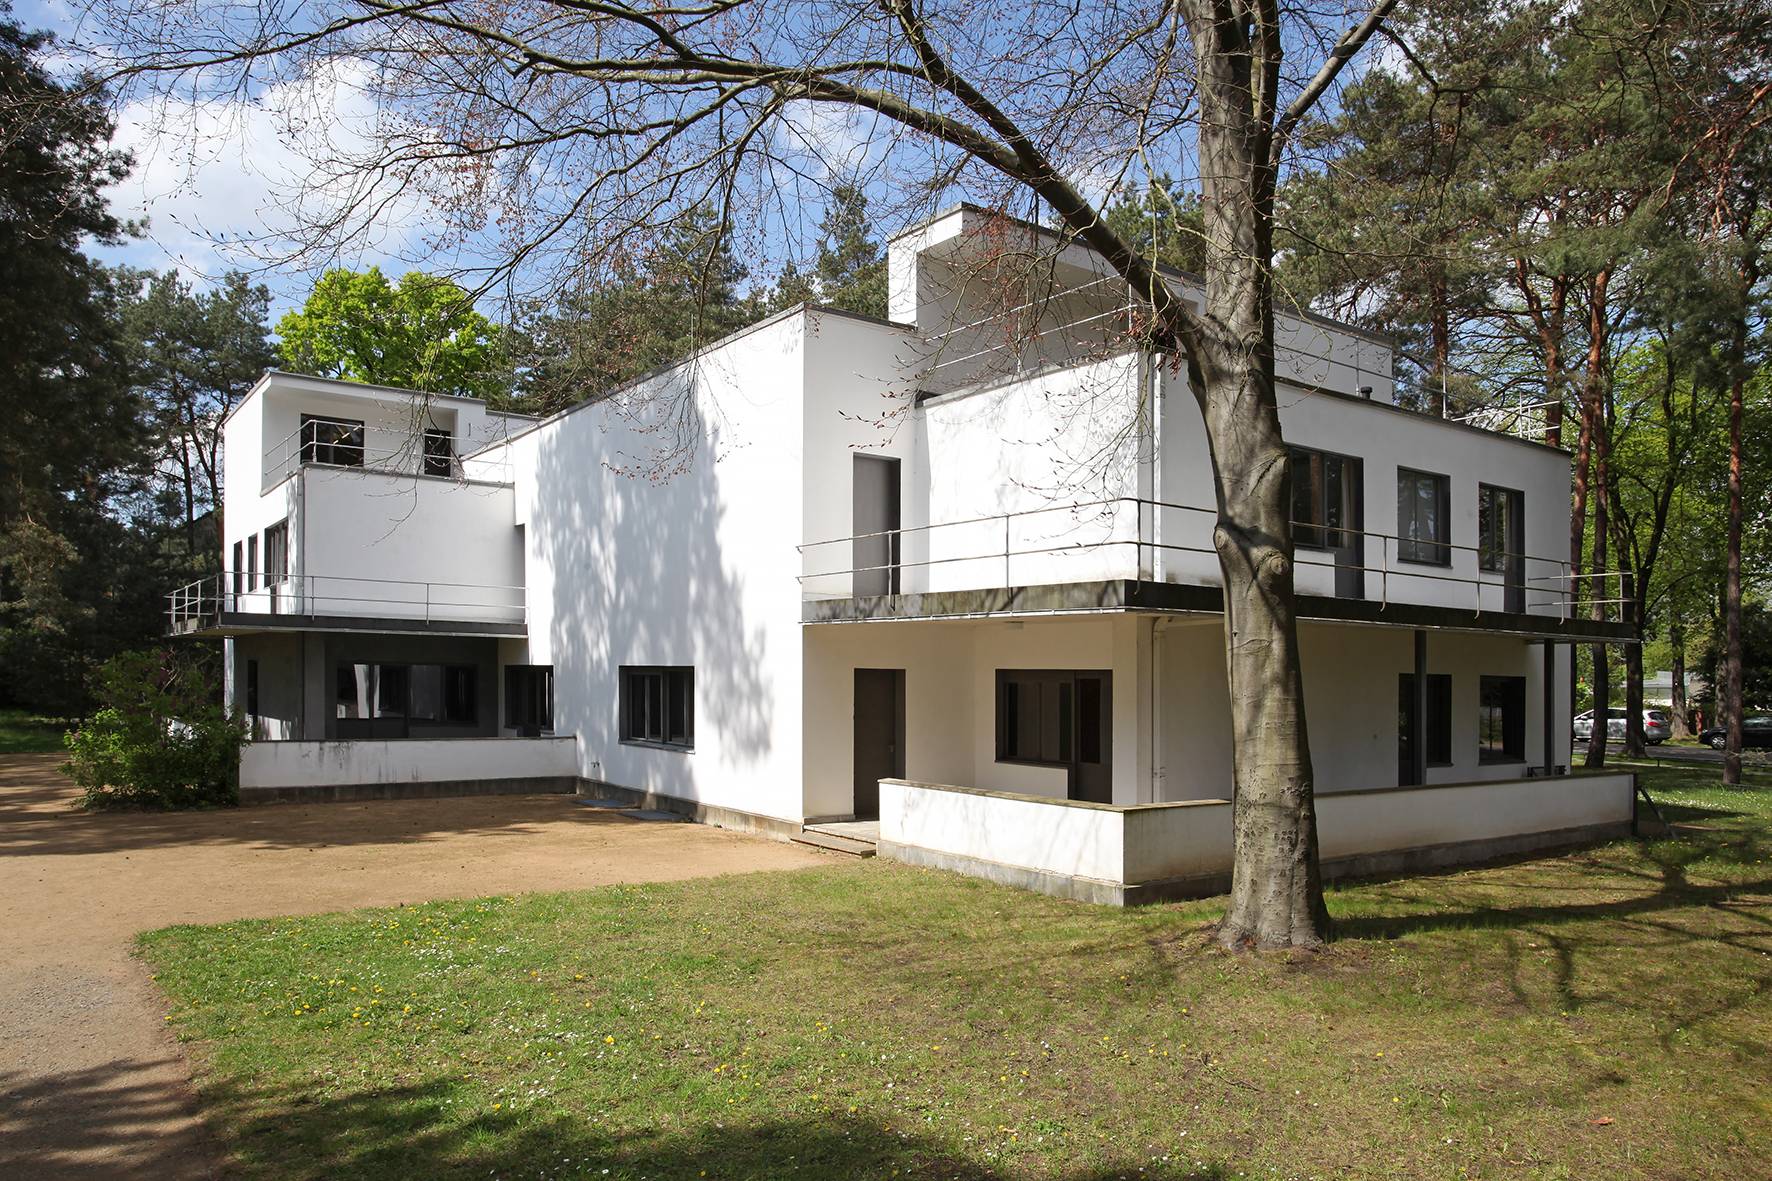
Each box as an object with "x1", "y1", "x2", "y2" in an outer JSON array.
[{"x1": 239, "y1": 734, "x2": 578, "y2": 787}]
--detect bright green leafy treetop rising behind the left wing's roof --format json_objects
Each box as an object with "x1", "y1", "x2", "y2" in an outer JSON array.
[{"x1": 276, "y1": 266, "x2": 510, "y2": 404}]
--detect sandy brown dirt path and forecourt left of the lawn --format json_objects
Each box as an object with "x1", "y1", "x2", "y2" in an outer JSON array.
[{"x1": 0, "y1": 755, "x2": 824, "y2": 1181}]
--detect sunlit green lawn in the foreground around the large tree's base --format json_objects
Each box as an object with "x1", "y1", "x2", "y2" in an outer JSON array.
[{"x1": 142, "y1": 768, "x2": 1772, "y2": 1181}]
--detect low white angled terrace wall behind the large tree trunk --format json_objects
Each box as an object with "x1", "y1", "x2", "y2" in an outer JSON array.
[{"x1": 881, "y1": 773, "x2": 1634, "y2": 885}]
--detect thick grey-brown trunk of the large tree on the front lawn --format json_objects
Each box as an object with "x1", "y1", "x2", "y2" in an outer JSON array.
[{"x1": 1187, "y1": 5, "x2": 1329, "y2": 947}]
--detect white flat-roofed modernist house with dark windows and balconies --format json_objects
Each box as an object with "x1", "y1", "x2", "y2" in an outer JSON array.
[{"x1": 172, "y1": 207, "x2": 1634, "y2": 901}]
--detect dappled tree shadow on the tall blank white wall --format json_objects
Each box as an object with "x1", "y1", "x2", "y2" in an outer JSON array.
[{"x1": 528, "y1": 370, "x2": 776, "y2": 780}]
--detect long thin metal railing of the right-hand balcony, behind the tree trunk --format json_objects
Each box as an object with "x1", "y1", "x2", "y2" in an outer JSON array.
[{"x1": 796, "y1": 497, "x2": 1628, "y2": 621}]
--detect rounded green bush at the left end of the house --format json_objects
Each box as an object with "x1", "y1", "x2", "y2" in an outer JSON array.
[{"x1": 62, "y1": 651, "x2": 246, "y2": 809}]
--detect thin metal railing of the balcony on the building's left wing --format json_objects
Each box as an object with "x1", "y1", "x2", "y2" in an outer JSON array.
[{"x1": 167, "y1": 571, "x2": 528, "y2": 635}]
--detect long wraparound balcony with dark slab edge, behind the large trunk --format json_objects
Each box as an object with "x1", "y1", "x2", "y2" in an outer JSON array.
[{"x1": 797, "y1": 497, "x2": 1634, "y2": 640}]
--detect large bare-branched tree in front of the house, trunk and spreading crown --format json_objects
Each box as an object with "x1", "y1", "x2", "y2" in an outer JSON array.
[{"x1": 92, "y1": 0, "x2": 1395, "y2": 947}]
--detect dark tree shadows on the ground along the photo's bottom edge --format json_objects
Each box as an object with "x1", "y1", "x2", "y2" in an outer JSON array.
[{"x1": 0, "y1": 1071, "x2": 1230, "y2": 1181}]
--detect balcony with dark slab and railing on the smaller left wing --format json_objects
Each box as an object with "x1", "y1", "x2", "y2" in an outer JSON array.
[{"x1": 167, "y1": 571, "x2": 528, "y2": 635}]
